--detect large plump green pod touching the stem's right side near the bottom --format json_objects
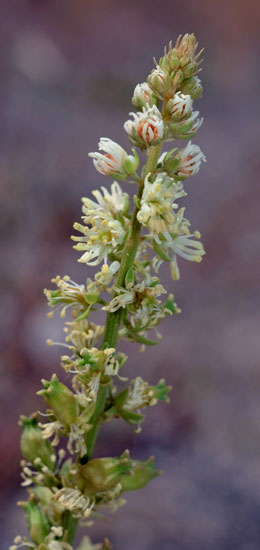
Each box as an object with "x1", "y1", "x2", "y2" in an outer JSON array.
[{"x1": 76, "y1": 451, "x2": 131, "y2": 496}]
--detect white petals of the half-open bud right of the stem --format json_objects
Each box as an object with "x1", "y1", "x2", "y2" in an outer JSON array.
[{"x1": 176, "y1": 141, "x2": 206, "y2": 179}]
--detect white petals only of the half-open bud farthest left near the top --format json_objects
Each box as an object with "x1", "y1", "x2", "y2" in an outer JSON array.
[{"x1": 89, "y1": 138, "x2": 127, "y2": 176}]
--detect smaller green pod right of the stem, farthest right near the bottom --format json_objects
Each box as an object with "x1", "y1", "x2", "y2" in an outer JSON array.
[{"x1": 120, "y1": 457, "x2": 161, "y2": 491}]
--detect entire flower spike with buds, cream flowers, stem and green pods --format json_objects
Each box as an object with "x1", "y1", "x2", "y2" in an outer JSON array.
[{"x1": 10, "y1": 35, "x2": 205, "y2": 550}]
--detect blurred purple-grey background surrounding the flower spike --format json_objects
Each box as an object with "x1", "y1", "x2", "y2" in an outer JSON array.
[{"x1": 0, "y1": 0, "x2": 260, "y2": 550}]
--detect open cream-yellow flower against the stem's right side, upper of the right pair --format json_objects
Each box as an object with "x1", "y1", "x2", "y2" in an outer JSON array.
[{"x1": 137, "y1": 174, "x2": 186, "y2": 239}]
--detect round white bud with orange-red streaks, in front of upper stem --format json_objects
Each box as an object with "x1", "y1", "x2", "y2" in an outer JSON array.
[{"x1": 124, "y1": 105, "x2": 164, "y2": 147}]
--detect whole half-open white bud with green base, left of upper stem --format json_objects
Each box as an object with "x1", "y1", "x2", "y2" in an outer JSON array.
[{"x1": 89, "y1": 138, "x2": 139, "y2": 179}]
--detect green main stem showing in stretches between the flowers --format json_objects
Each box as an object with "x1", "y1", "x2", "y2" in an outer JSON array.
[{"x1": 66, "y1": 144, "x2": 162, "y2": 544}]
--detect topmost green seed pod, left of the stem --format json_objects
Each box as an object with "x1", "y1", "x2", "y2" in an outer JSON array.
[{"x1": 37, "y1": 374, "x2": 78, "y2": 429}]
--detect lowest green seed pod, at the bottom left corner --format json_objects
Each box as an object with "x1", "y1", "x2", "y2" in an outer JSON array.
[{"x1": 18, "y1": 499, "x2": 49, "y2": 544}]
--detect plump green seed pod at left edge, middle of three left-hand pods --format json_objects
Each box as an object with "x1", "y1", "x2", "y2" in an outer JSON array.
[{"x1": 20, "y1": 416, "x2": 55, "y2": 470}]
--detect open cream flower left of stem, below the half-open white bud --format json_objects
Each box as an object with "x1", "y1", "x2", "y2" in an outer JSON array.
[{"x1": 71, "y1": 210, "x2": 125, "y2": 265}]
